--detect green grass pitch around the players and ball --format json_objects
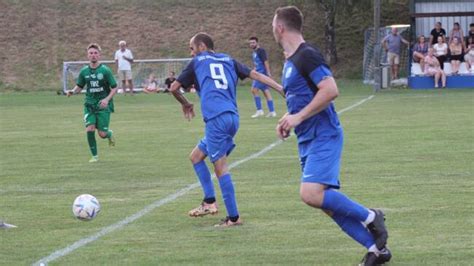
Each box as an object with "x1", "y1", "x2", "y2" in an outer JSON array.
[{"x1": 0, "y1": 81, "x2": 474, "y2": 265}]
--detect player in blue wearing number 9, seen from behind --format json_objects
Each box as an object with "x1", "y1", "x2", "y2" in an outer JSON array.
[{"x1": 170, "y1": 33, "x2": 283, "y2": 227}]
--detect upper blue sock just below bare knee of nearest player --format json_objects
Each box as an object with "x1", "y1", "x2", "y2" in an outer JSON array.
[{"x1": 322, "y1": 189, "x2": 369, "y2": 222}]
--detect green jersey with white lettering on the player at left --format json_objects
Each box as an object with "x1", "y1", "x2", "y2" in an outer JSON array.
[{"x1": 77, "y1": 64, "x2": 117, "y2": 112}]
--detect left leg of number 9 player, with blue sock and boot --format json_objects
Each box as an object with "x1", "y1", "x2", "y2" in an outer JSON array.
[{"x1": 188, "y1": 142, "x2": 218, "y2": 217}]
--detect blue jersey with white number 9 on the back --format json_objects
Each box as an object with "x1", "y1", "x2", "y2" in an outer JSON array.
[{"x1": 177, "y1": 52, "x2": 251, "y2": 122}]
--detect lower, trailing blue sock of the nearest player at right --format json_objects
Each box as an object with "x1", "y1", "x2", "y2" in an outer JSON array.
[{"x1": 331, "y1": 213, "x2": 375, "y2": 249}]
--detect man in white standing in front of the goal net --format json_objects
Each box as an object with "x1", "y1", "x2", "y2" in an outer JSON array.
[{"x1": 115, "y1": 40, "x2": 133, "y2": 95}]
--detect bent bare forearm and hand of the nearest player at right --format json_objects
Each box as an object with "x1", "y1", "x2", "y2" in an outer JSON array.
[{"x1": 278, "y1": 77, "x2": 339, "y2": 131}]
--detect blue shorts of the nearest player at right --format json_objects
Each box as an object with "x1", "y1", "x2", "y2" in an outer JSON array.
[{"x1": 298, "y1": 132, "x2": 344, "y2": 188}]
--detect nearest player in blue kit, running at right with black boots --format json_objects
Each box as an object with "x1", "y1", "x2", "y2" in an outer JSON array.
[{"x1": 272, "y1": 6, "x2": 391, "y2": 265}]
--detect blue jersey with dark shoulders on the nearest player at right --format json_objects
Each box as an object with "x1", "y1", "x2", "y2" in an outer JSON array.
[{"x1": 282, "y1": 43, "x2": 342, "y2": 143}]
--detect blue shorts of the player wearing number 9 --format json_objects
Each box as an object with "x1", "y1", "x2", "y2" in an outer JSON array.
[{"x1": 198, "y1": 112, "x2": 239, "y2": 163}]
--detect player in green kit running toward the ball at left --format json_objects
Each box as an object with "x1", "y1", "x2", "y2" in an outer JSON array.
[{"x1": 67, "y1": 43, "x2": 117, "y2": 163}]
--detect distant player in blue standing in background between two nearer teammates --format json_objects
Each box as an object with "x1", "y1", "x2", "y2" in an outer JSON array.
[{"x1": 249, "y1": 37, "x2": 276, "y2": 118}]
